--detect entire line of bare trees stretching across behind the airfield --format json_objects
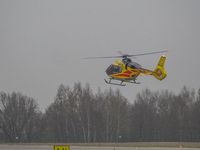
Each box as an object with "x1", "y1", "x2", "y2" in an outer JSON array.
[{"x1": 0, "y1": 83, "x2": 200, "y2": 143}]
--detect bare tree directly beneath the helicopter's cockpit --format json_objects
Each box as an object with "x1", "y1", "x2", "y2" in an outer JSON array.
[{"x1": 101, "y1": 88, "x2": 130, "y2": 142}]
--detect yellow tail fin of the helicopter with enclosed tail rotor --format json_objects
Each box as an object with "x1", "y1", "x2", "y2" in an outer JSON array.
[{"x1": 153, "y1": 55, "x2": 167, "y2": 80}]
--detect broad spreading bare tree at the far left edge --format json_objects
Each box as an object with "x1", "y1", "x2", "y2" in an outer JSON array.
[{"x1": 0, "y1": 92, "x2": 39, "y2": 142}]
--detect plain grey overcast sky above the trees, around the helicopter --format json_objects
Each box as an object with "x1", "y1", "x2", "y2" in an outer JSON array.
[{"x1": 0, "y1": 0, "x2": 200, "y2": 110}]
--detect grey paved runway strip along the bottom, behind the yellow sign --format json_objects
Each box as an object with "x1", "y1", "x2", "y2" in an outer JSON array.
[{"x1": 0, "y1": 145, "x2": 200, "y2": 150}]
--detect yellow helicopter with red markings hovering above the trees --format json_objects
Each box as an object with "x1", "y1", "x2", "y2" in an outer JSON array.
[{"x1": 86, "y1": 50, "x2": 170, "y2": 86}]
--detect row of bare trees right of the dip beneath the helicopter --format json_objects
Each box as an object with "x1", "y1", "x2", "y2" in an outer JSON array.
[{"x1": 131, "y1": 86, "x2": 200, "y2": 142}]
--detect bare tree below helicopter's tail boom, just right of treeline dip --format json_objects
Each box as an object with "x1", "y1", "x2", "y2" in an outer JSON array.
[{"x1": 132, "y1": 89, "x2": 158, "y2": 141}]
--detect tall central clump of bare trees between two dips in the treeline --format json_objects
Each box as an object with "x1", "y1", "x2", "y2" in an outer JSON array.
[{"x1": 46, "y1": 83, "x2": 131, "y2": 142}]
